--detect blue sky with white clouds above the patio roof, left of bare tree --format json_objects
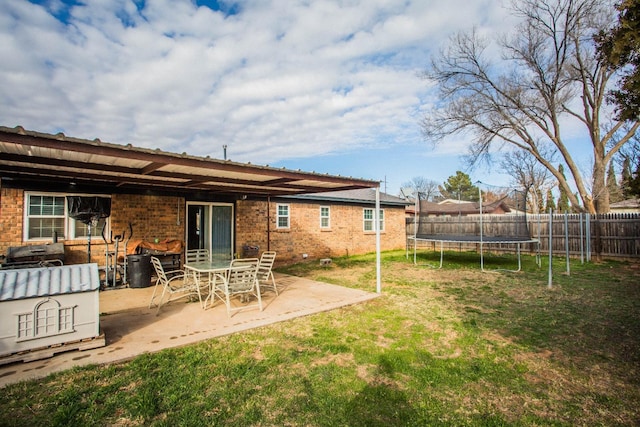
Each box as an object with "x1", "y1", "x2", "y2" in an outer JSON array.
[{"x1": 0, "y1": 0, "x2": 511, "y2": 194}]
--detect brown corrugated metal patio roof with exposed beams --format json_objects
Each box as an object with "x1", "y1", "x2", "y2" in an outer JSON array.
[{"x1": 0, "y1": 126, "x2": 379, "y2": 196}]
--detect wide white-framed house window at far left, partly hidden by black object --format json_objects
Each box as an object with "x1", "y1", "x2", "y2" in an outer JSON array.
[{"x1": 24, "y1": 193, "x2": 107, "y2": 240}]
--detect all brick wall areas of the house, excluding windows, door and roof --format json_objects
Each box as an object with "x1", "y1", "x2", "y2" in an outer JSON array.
[{"x1": 0, "y1": 188, "x2": 405, "y2": 265}]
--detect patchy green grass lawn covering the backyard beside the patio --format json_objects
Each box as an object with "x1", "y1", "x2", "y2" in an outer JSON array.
[{"x1": 0, "y1": 251, "x2": 640, "y2": 426}]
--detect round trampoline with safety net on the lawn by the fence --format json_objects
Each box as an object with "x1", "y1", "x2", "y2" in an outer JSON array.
[{"x1": 407, "y1": 186, "x2": 540, "y2": 272}]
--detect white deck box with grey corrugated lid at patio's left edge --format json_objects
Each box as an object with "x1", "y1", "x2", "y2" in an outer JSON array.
[{"x1": 0, "y1": 264, "x2": 104, "y2": 364}]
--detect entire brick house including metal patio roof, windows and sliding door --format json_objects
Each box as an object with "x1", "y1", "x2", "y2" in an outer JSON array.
[{"x1": 0, "y1": 127, "x2": 405, "y2": 270}]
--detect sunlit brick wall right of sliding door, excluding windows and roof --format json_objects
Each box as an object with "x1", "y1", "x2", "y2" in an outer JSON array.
[{"x1": 236, "y1": 201, "x2": 405, "y2": 263}]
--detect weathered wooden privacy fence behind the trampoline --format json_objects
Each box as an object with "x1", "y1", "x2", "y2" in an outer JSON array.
[{"x1": 407, "y1": 213, "x2": 640, "y2": 259}]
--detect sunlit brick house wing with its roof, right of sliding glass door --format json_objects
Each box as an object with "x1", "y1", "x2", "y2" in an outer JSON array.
[{"x1": 237, "y1": 189, "x2": 406, "y2": 261}]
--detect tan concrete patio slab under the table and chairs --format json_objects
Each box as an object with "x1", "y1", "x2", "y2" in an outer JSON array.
[{"x1": 0, "y1": 274, "x2": 379, "y2": 387}]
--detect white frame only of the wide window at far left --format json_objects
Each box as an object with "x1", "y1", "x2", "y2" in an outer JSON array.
[{"x1": 22, "y1": 191, "x2": 110, "y2": 242}]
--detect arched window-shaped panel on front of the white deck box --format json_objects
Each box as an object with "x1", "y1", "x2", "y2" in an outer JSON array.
[{"x1": 16, "y1": 300, "x2": 73, "y2": 341}]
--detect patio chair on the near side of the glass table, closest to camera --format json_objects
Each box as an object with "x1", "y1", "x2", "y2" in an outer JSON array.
[{"x1": 212, "y1": 258, "x2": 262, "y2": 317}]
